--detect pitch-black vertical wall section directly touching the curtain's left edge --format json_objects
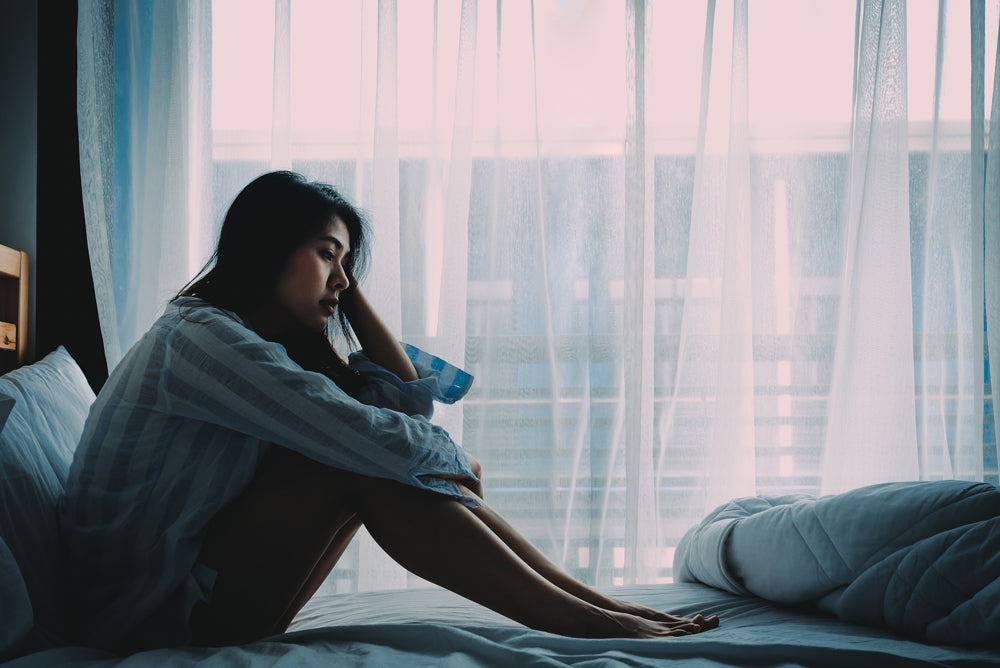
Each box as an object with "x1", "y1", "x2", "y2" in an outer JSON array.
[{"x1": 35, "y1": 0, "x2": 107, "y2": 390}]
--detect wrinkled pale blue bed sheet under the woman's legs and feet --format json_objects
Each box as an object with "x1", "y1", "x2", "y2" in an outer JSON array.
[{"x1": 5, "y1": 583, "x2": 1000, "y2": 668}]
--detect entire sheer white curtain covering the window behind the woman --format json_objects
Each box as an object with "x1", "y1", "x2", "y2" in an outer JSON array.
[{"x1": 79, "y1": 0, "x2": 1000, "y2": 590}]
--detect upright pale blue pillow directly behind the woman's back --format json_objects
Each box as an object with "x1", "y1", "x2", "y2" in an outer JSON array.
[{"x1": 0, "y1": 346, "x2": 94, "y2": 651}]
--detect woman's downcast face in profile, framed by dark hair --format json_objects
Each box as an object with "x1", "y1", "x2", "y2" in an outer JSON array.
[{"x1": 255, "y1": 218, "x2": 351, "y2": 333}]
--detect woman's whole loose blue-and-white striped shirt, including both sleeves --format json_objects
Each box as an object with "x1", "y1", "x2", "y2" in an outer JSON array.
[{"x1": 60, "y1": 298, "x2": 474, "y2": 649}]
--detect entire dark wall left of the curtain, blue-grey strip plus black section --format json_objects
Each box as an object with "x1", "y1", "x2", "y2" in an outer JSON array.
[{"x1": 0, "y1": 0, "x2": 107, "y2": 389}]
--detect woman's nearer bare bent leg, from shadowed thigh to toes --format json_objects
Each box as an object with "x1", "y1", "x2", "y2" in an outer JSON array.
[{"x1": 191, "y1": 454, "x2": 716, "y2": 645}]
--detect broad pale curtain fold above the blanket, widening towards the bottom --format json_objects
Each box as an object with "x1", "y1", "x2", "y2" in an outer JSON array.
[{"x1": 823, "y1": 0, "x2": 919, "y2": 493}]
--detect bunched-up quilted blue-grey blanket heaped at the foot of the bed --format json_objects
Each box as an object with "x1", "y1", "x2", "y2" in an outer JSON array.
[{"x1": 674, "y1": 480, "x2": 1000, "y2": 647}]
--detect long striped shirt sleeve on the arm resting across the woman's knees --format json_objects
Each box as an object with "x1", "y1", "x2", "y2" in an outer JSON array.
[{"x1": 157, "y1": 308, "x2": 477, "y2": 506}]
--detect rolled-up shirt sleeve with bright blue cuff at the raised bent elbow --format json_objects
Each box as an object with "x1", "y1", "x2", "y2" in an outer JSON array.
[{"x1": 348, "y1": 343, "x2": 473, "y2": 420}]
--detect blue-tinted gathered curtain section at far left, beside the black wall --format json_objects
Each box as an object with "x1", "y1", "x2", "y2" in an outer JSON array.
[{"x1": 78, "y1": 0, "x2": 212, "y2": 370}]
